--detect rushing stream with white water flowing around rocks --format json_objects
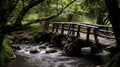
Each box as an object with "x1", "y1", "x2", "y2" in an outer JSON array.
[{"x1": 7, "y1": 44, "x2": 102, "y2": 67}]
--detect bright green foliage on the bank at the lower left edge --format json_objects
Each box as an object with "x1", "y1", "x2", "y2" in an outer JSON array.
[{"x1": 0, "y1": 35, "x2": 13, "y2": 67}]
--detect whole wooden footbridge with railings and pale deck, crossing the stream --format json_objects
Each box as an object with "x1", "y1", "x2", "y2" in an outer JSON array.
[{"x1": 45, "y1": 22, "x2": 115, "y2": 47}]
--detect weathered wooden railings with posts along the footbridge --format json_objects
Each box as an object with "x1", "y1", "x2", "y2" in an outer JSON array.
[{"x1": 46, "y1": 22, "x2": 114, "y2": 43}]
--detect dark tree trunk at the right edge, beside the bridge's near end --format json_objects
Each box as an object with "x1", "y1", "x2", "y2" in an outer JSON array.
[{"x1": 105, "y1": 0, "x2": 120, "y2": 52}]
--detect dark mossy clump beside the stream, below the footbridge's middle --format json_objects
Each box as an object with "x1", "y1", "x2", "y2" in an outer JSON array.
[{"x1": 63, "y1": 38, "x2": 84, "y2": 56}]
